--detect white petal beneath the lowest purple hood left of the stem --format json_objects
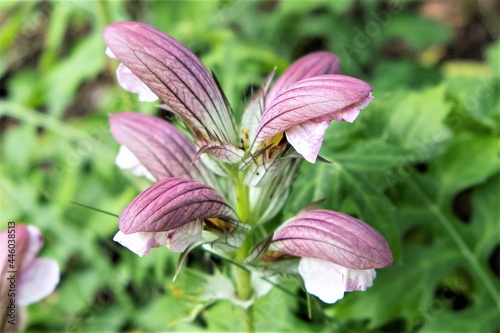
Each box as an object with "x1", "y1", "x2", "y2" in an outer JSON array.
[{"x1": 113, "y1": 231, "x2": 170, "y2": 257}]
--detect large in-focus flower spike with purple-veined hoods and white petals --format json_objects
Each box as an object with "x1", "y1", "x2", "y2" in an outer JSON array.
[{"x1": 104, "y1": 22, "x2": 392, "y2": 330}]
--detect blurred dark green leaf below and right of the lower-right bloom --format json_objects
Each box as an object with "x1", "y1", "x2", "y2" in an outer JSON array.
[{"x1": 327, "y1": 243, "x2": 462, "y2": 330}]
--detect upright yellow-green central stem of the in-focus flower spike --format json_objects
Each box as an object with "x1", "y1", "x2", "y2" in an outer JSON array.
[{"x1": 236, "y1": 174, "x2": 254, "y2": 332}]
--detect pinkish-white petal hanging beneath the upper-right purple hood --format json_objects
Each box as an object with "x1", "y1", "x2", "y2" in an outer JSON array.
[{"x1": 285, "y1": 117, "x2": 331, "y2": 163}]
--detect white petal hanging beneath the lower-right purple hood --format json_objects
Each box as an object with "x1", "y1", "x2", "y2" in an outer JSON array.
[{"x1": 299, "y1": 257, "x2": 347, "y2": 304}]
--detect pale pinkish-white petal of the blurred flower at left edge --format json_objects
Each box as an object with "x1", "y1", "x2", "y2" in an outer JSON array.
[{"x1": 17, "y1": 258, "x2": 60, "y2": 306}]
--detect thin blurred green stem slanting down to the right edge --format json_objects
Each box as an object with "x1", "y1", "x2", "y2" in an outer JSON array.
[{"x1": 408, "y1": 180, "x2": 500, "y2": 309}]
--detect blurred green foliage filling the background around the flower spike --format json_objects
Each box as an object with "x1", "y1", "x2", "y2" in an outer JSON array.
[{"x1": 0, "y1": 0, "x2": 500, "y2": 332}]
